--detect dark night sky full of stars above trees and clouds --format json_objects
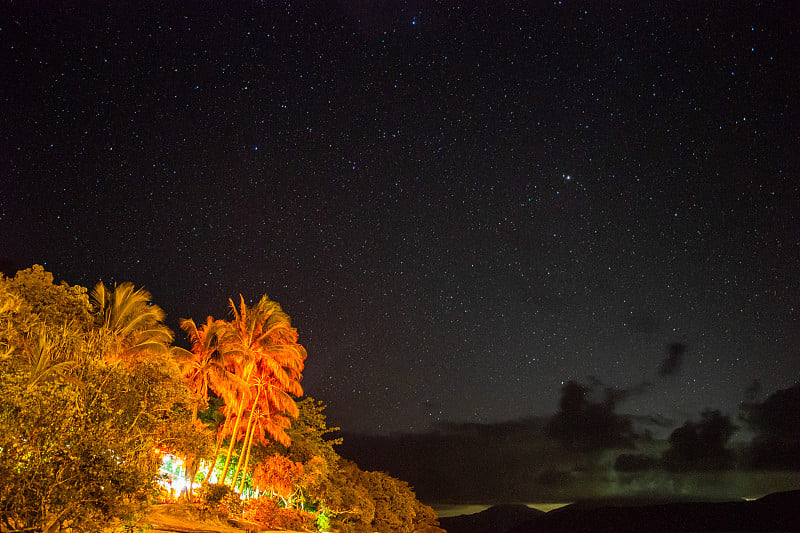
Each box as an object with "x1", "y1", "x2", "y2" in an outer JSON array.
[{"x1": 0, "y1": 1, "x2": 800, "y2": 434}]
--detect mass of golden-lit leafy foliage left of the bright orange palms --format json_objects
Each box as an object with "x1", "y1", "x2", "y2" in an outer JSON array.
[{"x1": 0, "y1": 266, "x2": 206, "y2": 532}]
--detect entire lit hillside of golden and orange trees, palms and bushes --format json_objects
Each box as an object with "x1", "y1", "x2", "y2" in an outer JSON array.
[{"x1": 0, "y1": 265, "x2": 436, "y2": 532}]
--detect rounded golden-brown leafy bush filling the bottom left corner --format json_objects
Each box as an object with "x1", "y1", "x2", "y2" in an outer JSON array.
[{"x1": 0, "y1": 368, "x2": 153, "y2": 531}]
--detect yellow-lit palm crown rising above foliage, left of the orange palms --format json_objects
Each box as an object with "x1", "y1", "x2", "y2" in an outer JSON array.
[{"x1": 90, "y1": 282, "x2": 173, "y2": 365}]
